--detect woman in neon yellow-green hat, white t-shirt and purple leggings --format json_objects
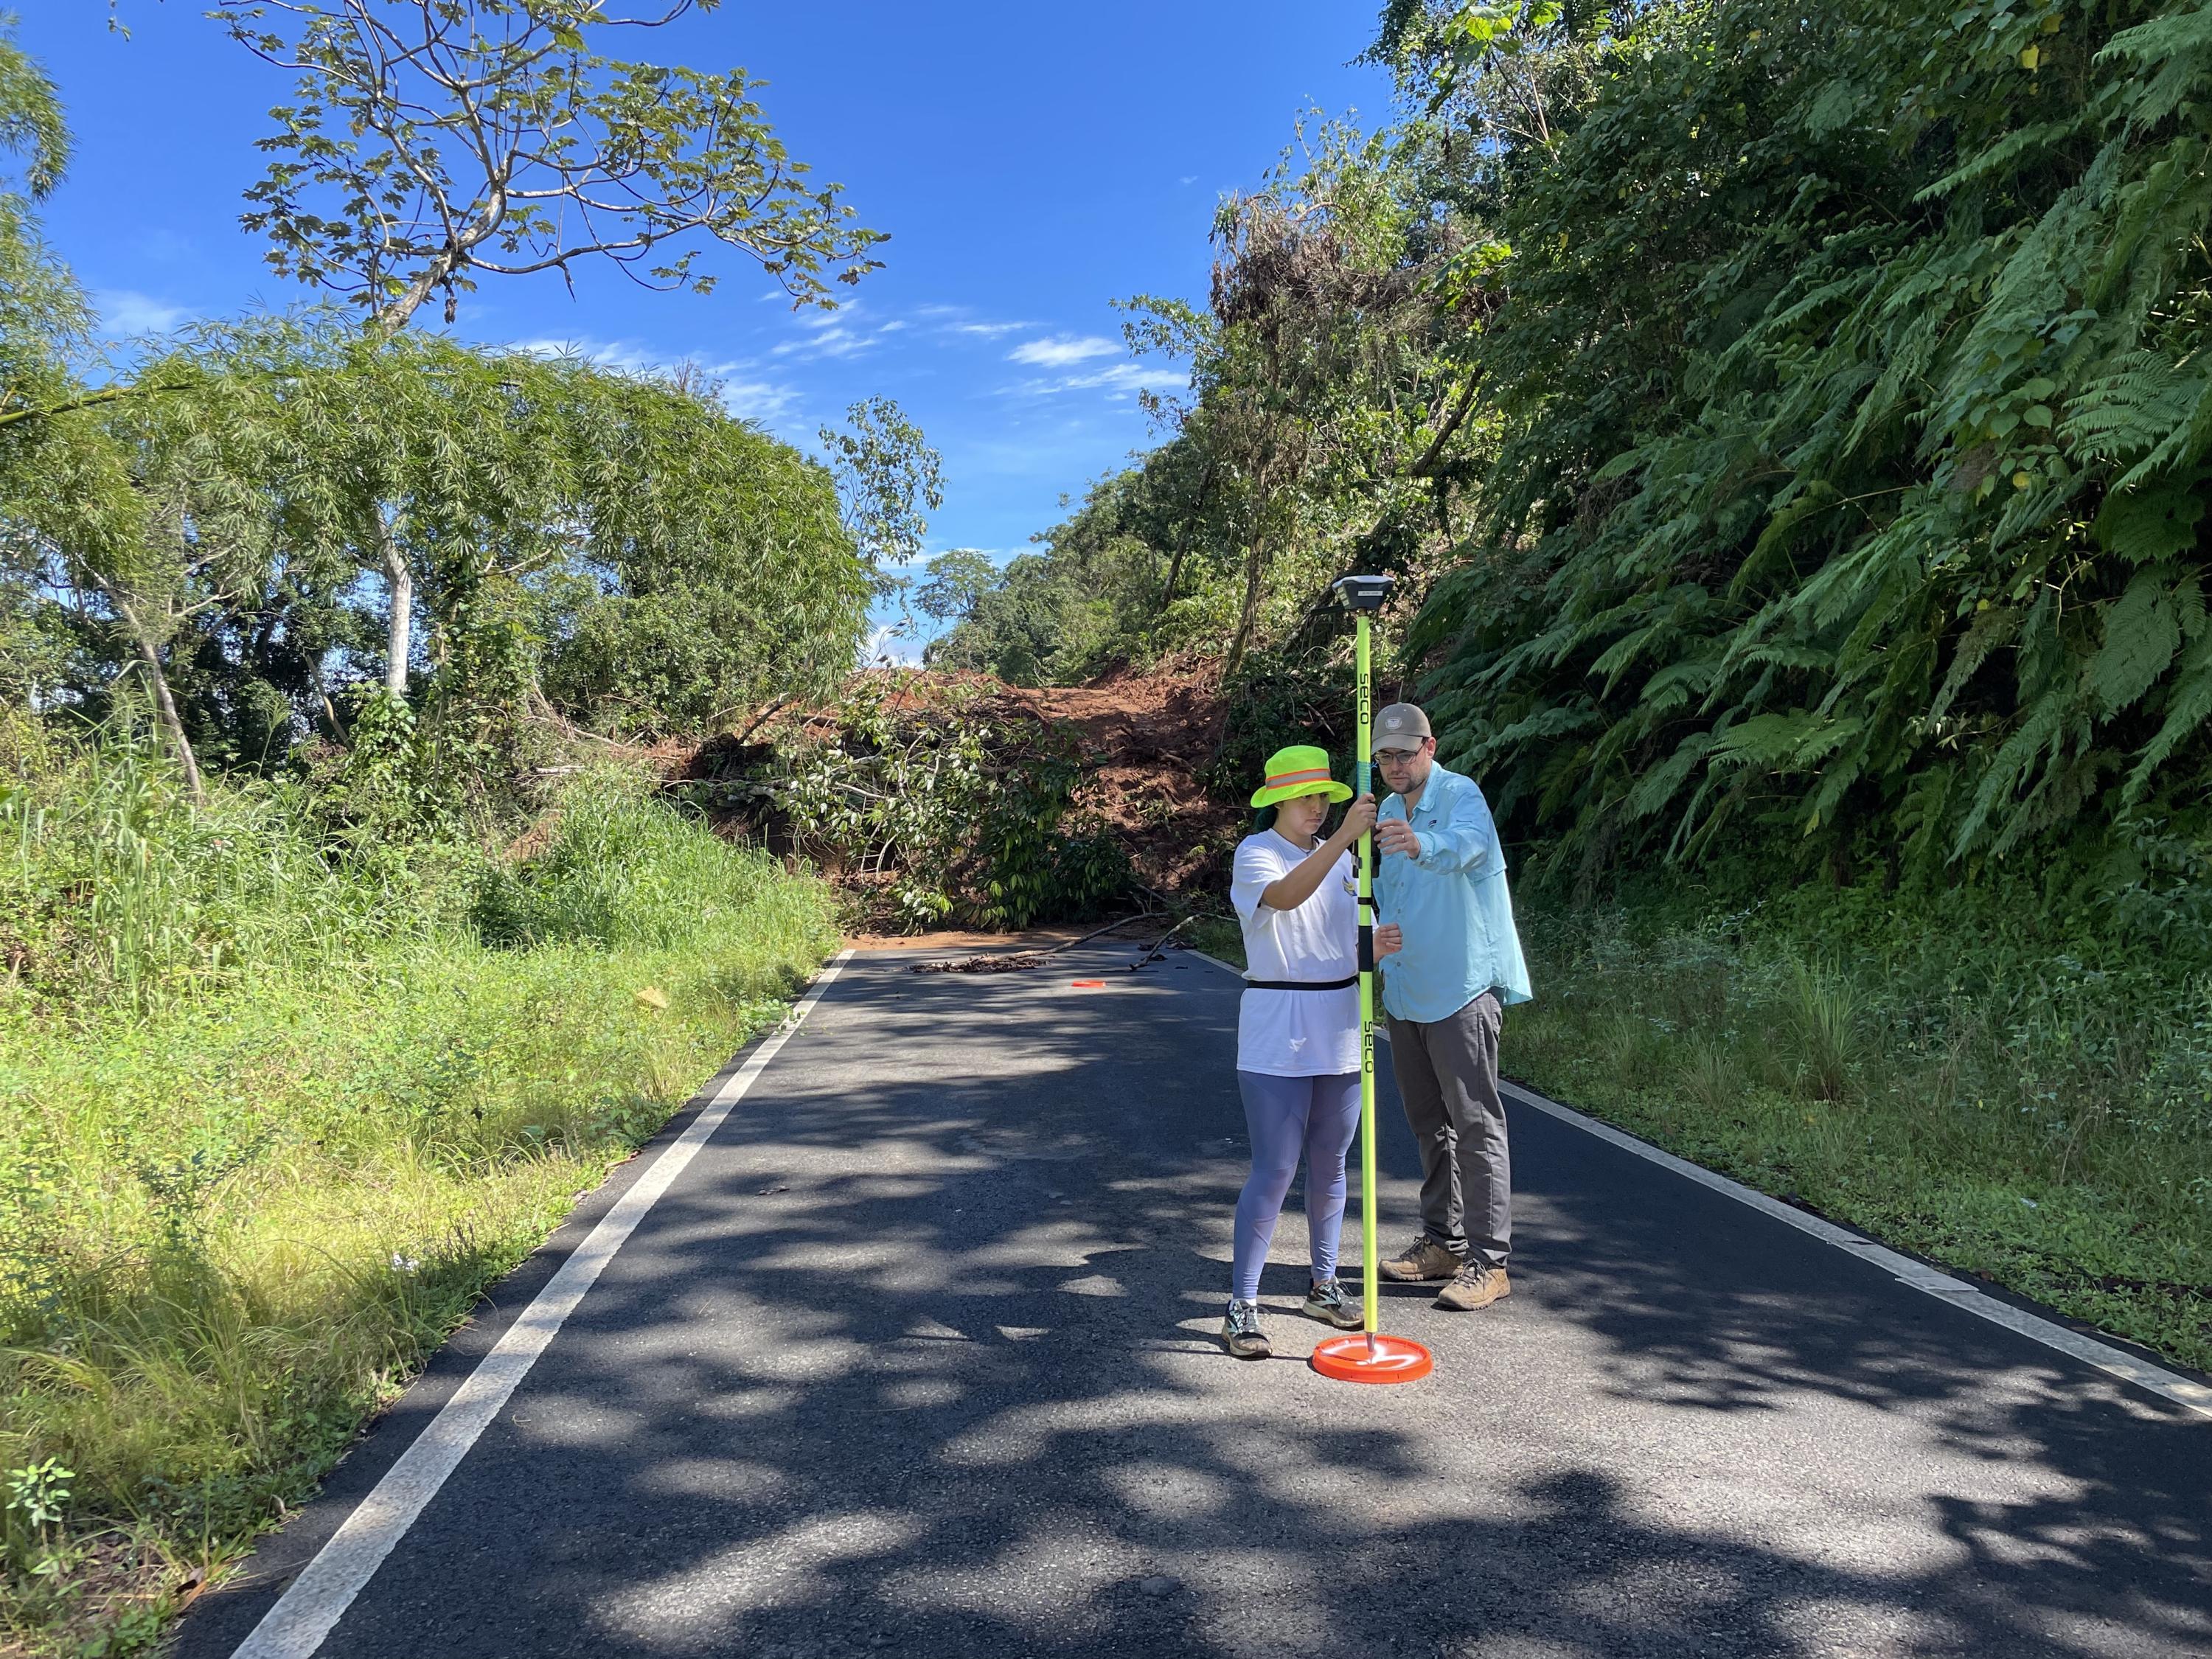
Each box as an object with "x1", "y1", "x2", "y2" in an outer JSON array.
[{"x1": 1221, "y1": 743, "x2": 1398, "y2": 1360}]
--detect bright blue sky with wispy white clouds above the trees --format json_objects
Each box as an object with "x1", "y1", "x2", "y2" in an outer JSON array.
[{"x1": 18, "y1": 0, "x2": 1387, "y2": 664}]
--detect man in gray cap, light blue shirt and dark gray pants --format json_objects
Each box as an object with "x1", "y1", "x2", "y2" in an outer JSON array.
[{"x1": 1374, "y1": 703, "x2": 1531, "y2": 1312}]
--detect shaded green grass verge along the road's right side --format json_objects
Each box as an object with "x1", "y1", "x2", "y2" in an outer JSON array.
[{"x1": 1192, "y1": 889, "x2": 2212, "y2": 1371}]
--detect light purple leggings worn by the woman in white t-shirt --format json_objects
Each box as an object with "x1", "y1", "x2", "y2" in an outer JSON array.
[{"x1": 1230, "y1": 1071, "x2": 1360, "y2": 1303}]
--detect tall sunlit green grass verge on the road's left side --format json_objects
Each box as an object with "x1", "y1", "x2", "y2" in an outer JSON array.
[{"x1": 0, "y1": 752, "x2": 836, "y2": 1655}]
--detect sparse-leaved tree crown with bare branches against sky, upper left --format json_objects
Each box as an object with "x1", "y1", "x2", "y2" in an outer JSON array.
[{"x1": 215, "y1": 0, "x2": 880, "y2": 332}]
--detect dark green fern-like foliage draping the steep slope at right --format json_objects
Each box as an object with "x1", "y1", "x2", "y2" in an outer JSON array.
[{"x1": 1416, "y1": 0, "x2": 2212, "y2": 872}]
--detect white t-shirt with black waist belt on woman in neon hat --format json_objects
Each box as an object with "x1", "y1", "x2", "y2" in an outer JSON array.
[{"x1": 1230, "y1": 830, "x2": 1360, "y2": 1077}]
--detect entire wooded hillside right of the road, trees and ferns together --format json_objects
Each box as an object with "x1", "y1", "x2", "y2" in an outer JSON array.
[{"x1": 940, "y1": 0, "x2": 2212, "y2": 898}]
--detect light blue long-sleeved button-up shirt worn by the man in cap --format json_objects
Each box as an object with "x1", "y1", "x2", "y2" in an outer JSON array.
[{"x1": 1376, "y1": 765, "x2": 1535, "y2": 1024}]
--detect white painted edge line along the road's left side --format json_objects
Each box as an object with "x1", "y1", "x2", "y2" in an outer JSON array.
[{"x1": 232, "y1": 949, "x2": 852, "y2": 1659}]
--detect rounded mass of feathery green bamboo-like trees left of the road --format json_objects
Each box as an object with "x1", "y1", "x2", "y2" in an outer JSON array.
[{"x1": 0, "y1": 321, "x2": 869, "y2": 776}]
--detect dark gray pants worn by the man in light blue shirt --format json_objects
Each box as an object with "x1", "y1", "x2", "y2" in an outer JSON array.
[{"x1": 1389, "y1": 991, "x2": 1513, "y2": 1267}]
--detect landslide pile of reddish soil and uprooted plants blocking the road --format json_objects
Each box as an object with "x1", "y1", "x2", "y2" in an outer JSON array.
[{"x1": 675, "y1": 668, "x2": 1243, "y2": 931}]
